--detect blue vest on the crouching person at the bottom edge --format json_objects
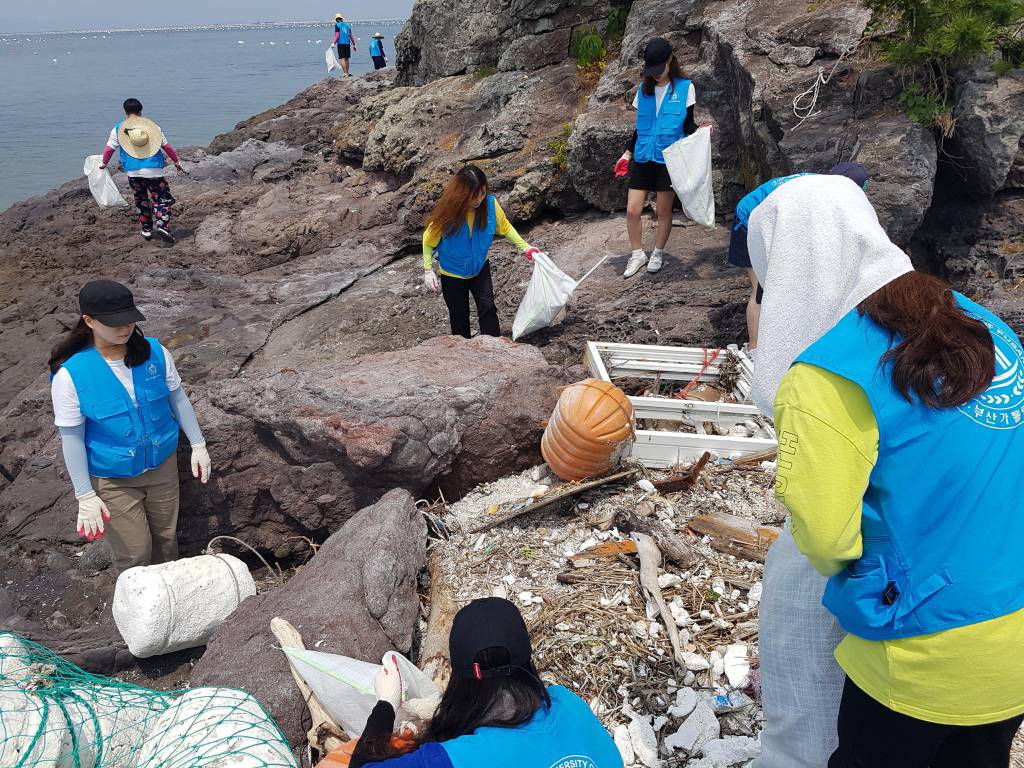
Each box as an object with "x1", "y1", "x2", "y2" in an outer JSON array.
[{"x1": 441, "y1": 685, "x2": 623, "y2": 768}]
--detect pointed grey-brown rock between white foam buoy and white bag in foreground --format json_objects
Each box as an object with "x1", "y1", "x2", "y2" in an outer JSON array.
[{"x1": 191, "y1": 490, "x2": 426, "y2": 748}]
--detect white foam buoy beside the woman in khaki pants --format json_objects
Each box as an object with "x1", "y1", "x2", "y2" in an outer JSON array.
[{"x1": 112, "y1": 555, "x2": 256, "y2": 658}]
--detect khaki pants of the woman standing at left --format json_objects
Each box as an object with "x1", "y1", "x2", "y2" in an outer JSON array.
[{"x1": 92, "y1": 456, "x2": 178, "y2": 574}]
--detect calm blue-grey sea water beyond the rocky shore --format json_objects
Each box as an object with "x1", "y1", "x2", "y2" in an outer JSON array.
[{"x1": 0, "y1": 19, "x2": 401, "y2": 211}]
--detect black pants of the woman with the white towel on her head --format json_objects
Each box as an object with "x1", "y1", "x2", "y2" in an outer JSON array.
[{"x1": 828, "y1": 678, "x2": 1024, "y2": 768}]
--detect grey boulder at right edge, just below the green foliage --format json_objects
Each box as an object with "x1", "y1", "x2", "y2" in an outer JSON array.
[{"x1": 948, "y1": 59, "x2": 1024, "y2": 196}]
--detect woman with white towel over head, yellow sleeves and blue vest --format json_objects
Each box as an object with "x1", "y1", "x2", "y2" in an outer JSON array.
[{"x1": 750, "y1": 176, "x2": 1024, "y2": 768}]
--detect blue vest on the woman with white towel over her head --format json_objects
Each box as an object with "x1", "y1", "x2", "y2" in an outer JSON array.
[{"x1": 797, "y1": 294, "x2": 1024, "y2": 640}]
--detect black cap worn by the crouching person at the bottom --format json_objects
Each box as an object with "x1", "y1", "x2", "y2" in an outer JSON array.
[{"x1": 449, "y1": 597, "x2": 536, "y2": 680}]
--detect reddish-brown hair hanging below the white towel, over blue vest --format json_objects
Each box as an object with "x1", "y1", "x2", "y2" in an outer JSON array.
[{"x1": 858, "y1": 271, "x2": 995, "y2": 409}]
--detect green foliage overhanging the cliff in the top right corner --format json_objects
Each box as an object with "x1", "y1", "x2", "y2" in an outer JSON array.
[{"x1": 865, "y1": 0, "x2": 1024, "y2": 135}]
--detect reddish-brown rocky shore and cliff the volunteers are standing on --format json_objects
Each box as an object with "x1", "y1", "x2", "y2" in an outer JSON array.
[{"x1": 0, "y1": 0, "x2": 1024, "y2": 692}]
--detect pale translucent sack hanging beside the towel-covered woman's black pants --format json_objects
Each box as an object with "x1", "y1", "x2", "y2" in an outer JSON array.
[{"x1": 753, "y1": 525, "x2": 845, "y2": 768}]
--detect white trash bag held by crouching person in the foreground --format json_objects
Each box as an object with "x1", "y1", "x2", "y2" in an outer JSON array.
[{"x1": 282, "y1": 648, "x2": 441, "y2": 738}]
